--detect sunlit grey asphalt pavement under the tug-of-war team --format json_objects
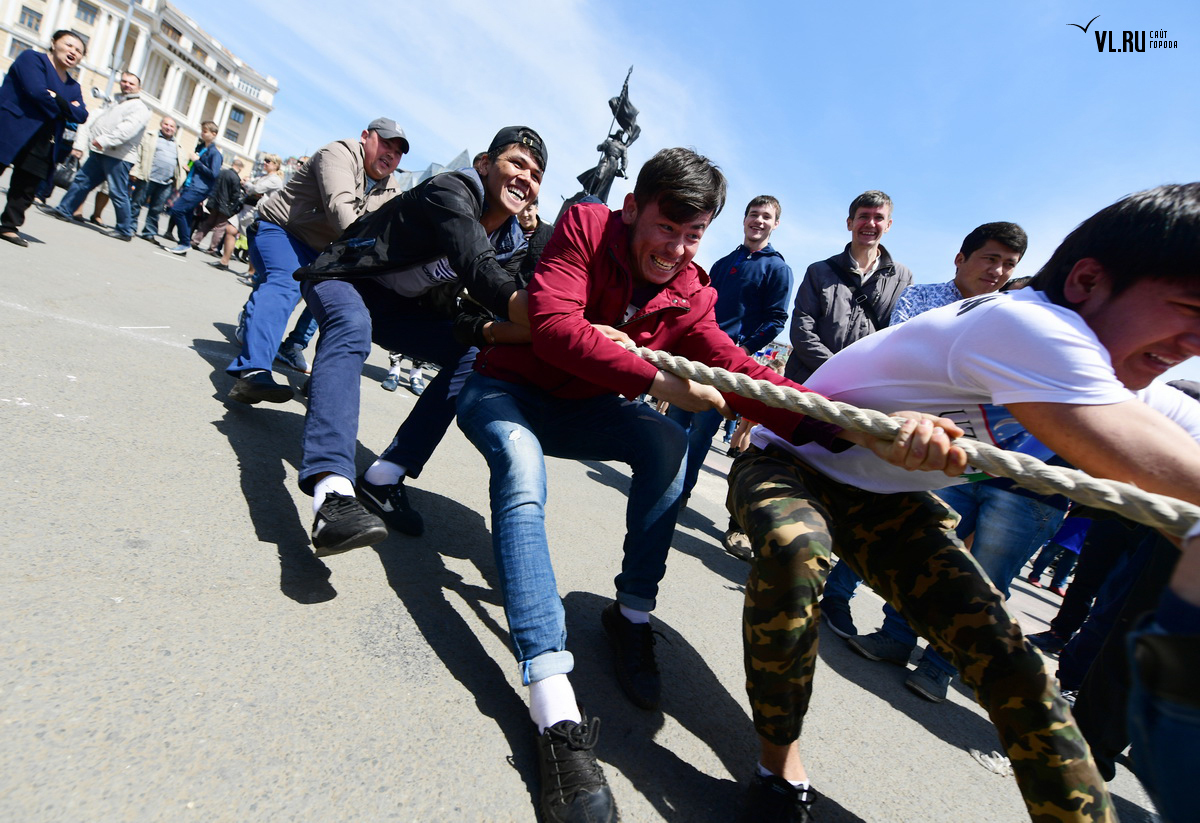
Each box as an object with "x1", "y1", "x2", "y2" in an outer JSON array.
[{"x1": 0, "y1": 193, "x2": 1151, "y2": 823}]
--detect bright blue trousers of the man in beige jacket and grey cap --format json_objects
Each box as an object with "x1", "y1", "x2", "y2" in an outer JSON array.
[{"x1": 225, "y1": 220, "x2": 317, "y2": 377}]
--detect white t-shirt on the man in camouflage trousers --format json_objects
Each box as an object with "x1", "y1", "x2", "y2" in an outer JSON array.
[{"x1": 751, "y1": 289, "x2": 1200, "y2": 493}]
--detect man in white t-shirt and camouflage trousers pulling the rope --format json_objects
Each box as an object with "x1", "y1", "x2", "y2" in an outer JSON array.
[{"x1": 730, "y1": 184, "x2": 1200, "y2": 821}]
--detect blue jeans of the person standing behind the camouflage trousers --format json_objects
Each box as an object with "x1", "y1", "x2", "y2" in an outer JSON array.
[{"x1": 883, "y1": 483, "x2": 1067, "y2": 675}]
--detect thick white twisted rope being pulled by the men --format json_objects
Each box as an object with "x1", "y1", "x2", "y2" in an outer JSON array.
[{"x1": 624, "y1": 344, "x2": 1200, "y2": 536}]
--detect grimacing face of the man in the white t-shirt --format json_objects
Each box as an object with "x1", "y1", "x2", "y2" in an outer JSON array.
[{"x1": 1063, "y1": 258, "x2": 1200, "y2": 391}]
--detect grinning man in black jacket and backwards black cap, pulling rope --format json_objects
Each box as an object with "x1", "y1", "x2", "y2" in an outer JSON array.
[{"x1": 290, "y1": 126, "x2": 546, "y2": 557}]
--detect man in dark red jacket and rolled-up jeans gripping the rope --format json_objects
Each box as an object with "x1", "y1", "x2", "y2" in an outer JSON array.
[{"x1": 458, "y1": 149, "x2": 965, "y2": 821}]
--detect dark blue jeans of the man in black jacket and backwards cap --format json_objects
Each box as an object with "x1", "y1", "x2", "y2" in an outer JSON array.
[{"x1": 297, "y1": 277, "x2": 474, "y2": 494}]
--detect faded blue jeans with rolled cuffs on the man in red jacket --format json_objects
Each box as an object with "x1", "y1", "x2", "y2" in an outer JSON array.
[{"x1": 456, "y1": 376, "x2": 688, "y2": 685}]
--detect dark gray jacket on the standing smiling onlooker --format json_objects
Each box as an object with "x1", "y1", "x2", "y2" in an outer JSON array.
[{"x1": 784, "y1": 244, "x2": 912, "y2": 383}]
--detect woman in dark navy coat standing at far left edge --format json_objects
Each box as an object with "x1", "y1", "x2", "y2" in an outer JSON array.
[{"x1": 0, "y1": 30, "x2": 88, "y2": 246}]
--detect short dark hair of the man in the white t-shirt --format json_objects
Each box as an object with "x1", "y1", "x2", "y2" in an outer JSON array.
[{"x1": 1030, "y1": 182, "x2": 1200, "y2": 306}]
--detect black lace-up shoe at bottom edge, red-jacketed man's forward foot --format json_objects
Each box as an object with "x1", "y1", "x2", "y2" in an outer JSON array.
[{"x1": 538, "y1": 717, "x2": 617, "y2": 823}]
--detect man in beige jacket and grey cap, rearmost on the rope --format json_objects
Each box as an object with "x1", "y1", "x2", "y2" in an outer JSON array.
[{"x1": 226, "y1": 118, "x2": 408, "y2": 403}]
